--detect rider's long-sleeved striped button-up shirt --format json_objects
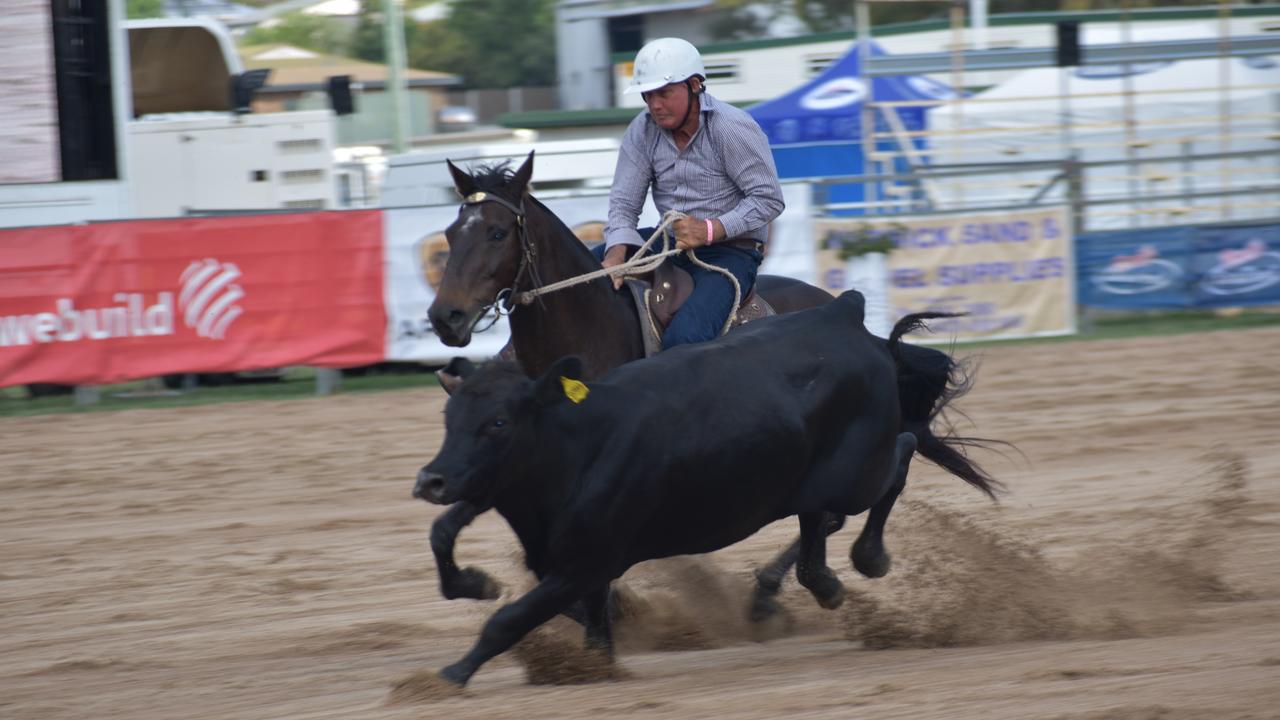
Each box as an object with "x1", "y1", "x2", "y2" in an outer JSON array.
[{"x1": 604, "y1": 92, "x2": 783, "y2": 247}]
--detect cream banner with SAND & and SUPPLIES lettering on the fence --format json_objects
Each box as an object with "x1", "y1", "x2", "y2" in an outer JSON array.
[{"x1": 815, "y1": 208, "x2": 1075, "y2": 341}]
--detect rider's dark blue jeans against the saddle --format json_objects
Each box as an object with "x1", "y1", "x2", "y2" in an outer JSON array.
[{"x1": 591, "y1": 228, "x2": 764, "y2": 350}]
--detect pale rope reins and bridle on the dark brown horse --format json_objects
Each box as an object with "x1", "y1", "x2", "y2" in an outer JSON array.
[{"x1": 462, "y1": 192, "x2": 742, "y2": 334}]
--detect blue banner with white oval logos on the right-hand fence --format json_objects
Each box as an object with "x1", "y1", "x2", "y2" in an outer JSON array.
[{"x1": 1076, "y1": 224, "x2": 1280, "y2": 310}]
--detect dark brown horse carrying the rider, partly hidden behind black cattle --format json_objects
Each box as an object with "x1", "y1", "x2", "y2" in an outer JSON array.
[{"x1": 428, "y1": 152, "x2": 997, "y2": 619}]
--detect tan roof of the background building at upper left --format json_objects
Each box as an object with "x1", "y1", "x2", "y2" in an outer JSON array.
[{"x1": 238, "y1": 44, "x2": 462, "y2": 86}]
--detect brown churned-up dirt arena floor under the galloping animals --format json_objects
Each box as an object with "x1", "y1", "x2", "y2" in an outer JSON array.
[{"x1": 0, "y1": 328, "x2": 1280, "y2": 720}]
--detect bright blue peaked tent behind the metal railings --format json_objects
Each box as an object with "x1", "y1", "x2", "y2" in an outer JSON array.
[{"x1": 748, "y1": 42, "x2": 955, "y2": 210}]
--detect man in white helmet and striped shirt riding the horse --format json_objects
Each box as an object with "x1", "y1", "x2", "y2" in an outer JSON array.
[{"x1": 603, "y1": 37, "x2": 783, "y2": 347}]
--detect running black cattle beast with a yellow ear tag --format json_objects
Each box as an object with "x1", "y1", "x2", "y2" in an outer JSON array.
[{"x1": 413, "y1": 291, "x2": 988, "y2": 684}]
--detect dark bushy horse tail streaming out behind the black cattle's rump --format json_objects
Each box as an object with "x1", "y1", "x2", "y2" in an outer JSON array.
[{"x1": 888, "y1": 313, "x2": 1001, "y2": 498}]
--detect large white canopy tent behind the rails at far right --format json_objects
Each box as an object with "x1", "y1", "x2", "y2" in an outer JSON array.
[{"x1": 928, "y1": 24, "x2": 1280, "y2": 229}]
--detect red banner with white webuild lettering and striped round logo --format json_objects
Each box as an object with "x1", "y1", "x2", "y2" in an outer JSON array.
[{"x1": 0, "y1": 210, "x2": 387, "y2": 387}]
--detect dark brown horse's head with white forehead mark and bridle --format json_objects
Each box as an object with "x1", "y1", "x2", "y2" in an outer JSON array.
[{"x1": 428, "y1": 152, "x2": 534, "y2": 347}]
